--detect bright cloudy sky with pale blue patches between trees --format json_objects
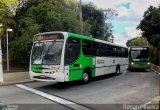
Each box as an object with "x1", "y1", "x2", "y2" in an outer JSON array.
[{"x1": 82, "y1": 0, "x2": 160, "y2": 45}]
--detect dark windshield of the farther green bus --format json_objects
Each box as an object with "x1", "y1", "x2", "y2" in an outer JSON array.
[{"x1": 131, "y1": 49, "x2": 149, "y2": 61}]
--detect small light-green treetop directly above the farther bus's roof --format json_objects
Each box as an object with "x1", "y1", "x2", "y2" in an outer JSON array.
[{"x1": 126, "y1": 37, "x2": 148, "y2": 47}]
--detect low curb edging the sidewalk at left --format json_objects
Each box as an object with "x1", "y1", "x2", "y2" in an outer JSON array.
[{"x1": 0, "y1": 80, "x2": 36, "y2": 86}]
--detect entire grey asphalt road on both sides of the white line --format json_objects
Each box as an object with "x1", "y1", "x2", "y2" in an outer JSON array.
[{"x1": 0, "y1": 71, "x2": 160, "y2": 109}]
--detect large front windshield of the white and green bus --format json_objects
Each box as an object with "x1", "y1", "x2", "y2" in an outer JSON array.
[{"x1": 31, "y1": 41, "x2": 63, "y2": 65}]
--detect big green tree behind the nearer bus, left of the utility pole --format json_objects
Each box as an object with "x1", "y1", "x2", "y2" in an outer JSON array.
[{"x1": 10, "y1": 0, "x2": 91, "y2": 64}]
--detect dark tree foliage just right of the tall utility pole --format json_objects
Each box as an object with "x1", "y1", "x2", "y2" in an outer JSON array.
[{"x1": 82, "y1": 3, "x2": 112, "y2": 40}]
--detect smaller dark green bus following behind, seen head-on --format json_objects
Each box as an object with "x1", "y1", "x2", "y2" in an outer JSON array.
[{"x1": 129, "y1": 46, "x2": 150, "y2": 70}]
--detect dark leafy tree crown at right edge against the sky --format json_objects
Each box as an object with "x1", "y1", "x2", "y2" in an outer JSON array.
[{"x1": 138, "y1": 6, "x2": 160, "y2": 47}]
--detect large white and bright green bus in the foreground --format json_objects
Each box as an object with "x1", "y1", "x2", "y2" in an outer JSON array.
[{"x1": 29, "y1": 31, "x2": 128, "y2": 83}]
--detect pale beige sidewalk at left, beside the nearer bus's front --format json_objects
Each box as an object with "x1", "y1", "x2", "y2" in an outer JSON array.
[{"x1": 0, "y1": 72, "x2": 31, "y2": 86}]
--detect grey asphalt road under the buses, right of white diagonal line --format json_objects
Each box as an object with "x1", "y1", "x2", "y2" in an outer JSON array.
[{"x1": 25, "y1": 71, "x2": 159, "y2": 106}]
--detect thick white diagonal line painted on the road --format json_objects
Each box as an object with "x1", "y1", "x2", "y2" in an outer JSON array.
[{"x1": 16, "y1": 84, "x2": 92, "y2": 110}]
